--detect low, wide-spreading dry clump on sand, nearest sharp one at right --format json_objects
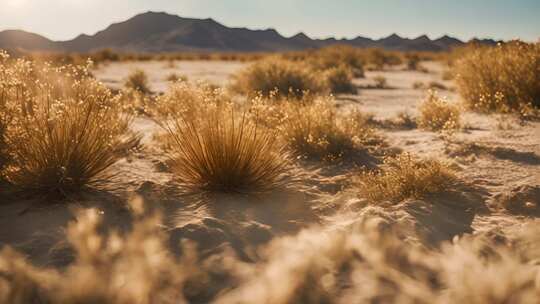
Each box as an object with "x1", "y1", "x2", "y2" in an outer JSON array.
[{"x1": 358, "y1": 153, "x2": 456, "y2": 202}]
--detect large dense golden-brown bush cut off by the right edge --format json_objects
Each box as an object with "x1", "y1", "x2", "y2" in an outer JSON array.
[{"x1": 454, "y1": 41, "x2": 540, "y2": 116}]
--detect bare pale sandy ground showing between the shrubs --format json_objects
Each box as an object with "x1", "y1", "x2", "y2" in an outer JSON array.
[{"x1": 0, "y1": 61, "x2": 540, "y2": 266}]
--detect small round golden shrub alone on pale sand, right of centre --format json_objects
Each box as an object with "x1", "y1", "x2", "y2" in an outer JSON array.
[{"x1": 417, "y1": 91, "x2": 461, "y2": 132}]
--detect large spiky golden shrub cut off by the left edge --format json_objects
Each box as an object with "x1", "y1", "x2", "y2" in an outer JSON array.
[{"x1": 0, "y1": 52, "x2": 129, "y2": 195}]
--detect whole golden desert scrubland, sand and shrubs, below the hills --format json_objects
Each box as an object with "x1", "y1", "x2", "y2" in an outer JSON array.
[{"x1": 0, "y1": 42, "x2": 540, "y2": 303}]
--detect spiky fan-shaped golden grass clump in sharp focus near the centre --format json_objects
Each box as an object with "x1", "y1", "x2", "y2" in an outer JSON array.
[{"x1": 153, "y1": 83, "x2": 287, "y2": 192}]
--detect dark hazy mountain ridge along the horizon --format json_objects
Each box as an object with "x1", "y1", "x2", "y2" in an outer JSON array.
[{"x1": 0, "y1": 12, "x2": 496, "y2": 53}]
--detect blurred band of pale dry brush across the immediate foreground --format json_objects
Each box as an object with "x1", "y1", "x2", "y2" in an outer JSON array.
[{"x1": 0, "y1": 202, "x2": 540, "y2": 304}]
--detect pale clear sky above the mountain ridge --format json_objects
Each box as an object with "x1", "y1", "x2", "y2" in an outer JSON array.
[{"x1": 0, "y1": 0, "x2": 540, "y2": 41}]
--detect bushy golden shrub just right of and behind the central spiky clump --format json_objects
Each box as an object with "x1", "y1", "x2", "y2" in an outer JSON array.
[{"x1": 280, "y1": 97, "x2": 373, "y2": 161}]
